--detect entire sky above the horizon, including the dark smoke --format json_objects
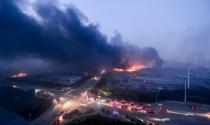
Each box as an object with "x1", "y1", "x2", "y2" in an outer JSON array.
[{"x1": 0, "y1": 0, "x2": 210, "y2": 73}]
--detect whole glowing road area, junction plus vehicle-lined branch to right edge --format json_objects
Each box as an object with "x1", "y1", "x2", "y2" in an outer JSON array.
[{"x1": 10, "y1": 75, "x2": 210, "y2": 125}]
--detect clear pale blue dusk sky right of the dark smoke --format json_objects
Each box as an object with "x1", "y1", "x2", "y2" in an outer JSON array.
[{"x1": 72, "y1": 0, "x2": 210, "y2": 61}]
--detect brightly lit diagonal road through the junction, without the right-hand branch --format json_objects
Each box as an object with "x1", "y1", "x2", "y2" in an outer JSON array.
[{"x1": 32, "y1": 76, "x2": 98, "y2": 125}]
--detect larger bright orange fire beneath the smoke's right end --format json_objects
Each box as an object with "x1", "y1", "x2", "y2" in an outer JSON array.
[{"x1": 113, "y1": 64, "x2": 145, "y2": 72}]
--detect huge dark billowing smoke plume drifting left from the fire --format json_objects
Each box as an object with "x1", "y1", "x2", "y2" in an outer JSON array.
[{"x1": 0, "y1": 0, "x2": 161, "y2": 71}]
